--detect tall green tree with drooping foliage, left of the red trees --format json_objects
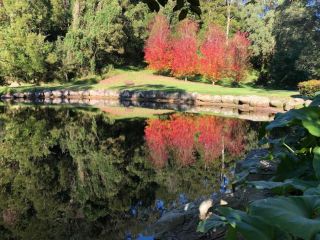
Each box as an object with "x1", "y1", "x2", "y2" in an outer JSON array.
[{"x1": 64, "y1": 0, "x2": 127, "y2": 74}]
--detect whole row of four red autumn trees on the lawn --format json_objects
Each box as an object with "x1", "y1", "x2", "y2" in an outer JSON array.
[{"x1": 145, "y1": 15, "x2": 250, "y2": 84}]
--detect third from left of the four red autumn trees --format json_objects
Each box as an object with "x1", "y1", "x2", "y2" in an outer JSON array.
[{"x1": 199, "y1": 26, "x2": 227, "y2": 84}]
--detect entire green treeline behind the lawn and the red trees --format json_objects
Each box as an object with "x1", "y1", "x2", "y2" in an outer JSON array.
[{"x1": 0, "y1": 0, "x2": 320, "y2": 87}]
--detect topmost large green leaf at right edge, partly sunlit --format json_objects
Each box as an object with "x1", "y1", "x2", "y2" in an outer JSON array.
[{"x1": 266, "y1": 107, "x2": 320, "y2": 137}]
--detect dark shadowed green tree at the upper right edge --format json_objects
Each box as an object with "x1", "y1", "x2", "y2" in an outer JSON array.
[{"x1": 269, "y1": 0, "x2": 320, "y2": 88}]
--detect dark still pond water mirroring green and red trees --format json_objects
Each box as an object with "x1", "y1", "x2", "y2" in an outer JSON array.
[{"x1": 0, "y1": 106, "x2": 262, "y2": 240}]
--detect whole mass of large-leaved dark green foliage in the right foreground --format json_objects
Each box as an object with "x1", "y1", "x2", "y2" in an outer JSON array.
[{"x1": 198, "y1": 97, "x2": 320, "y2": 240}]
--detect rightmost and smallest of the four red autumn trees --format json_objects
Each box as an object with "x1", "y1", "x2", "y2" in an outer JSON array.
[{"x1": 228, "y1": 32, "x2": 250, "y2": 83}]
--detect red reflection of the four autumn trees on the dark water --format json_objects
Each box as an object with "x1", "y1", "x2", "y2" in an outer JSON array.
[{"x1": 145, "y1": 115, "x2": 246, "y2": 167}]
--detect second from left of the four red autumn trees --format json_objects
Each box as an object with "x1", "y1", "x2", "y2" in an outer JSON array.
[{"x1": 171, "y1": 19, "x2": 198, "y2": 78}]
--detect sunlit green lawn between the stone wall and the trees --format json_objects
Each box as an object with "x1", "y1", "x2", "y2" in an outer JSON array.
[{"x1": 0, "y1": 69, "x2": 299, "y2": 97}]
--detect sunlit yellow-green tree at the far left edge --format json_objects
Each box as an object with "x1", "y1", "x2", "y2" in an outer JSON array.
[{"x1": 0, "y1": 0, "x2": 67, "y2": 83}]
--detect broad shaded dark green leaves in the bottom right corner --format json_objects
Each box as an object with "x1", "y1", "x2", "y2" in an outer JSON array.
[{"x1": 198, "y1": 195, "x2": 320, "y2": 240}]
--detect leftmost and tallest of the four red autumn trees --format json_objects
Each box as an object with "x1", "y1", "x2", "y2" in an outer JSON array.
[{"x1": 144, "y1": 15, "x2": 171, "y2": 71}]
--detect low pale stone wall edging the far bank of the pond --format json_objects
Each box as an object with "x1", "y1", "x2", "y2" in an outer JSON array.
[{"x1": 1, "y1": 90, "x2": 311, "y2": 112}]
